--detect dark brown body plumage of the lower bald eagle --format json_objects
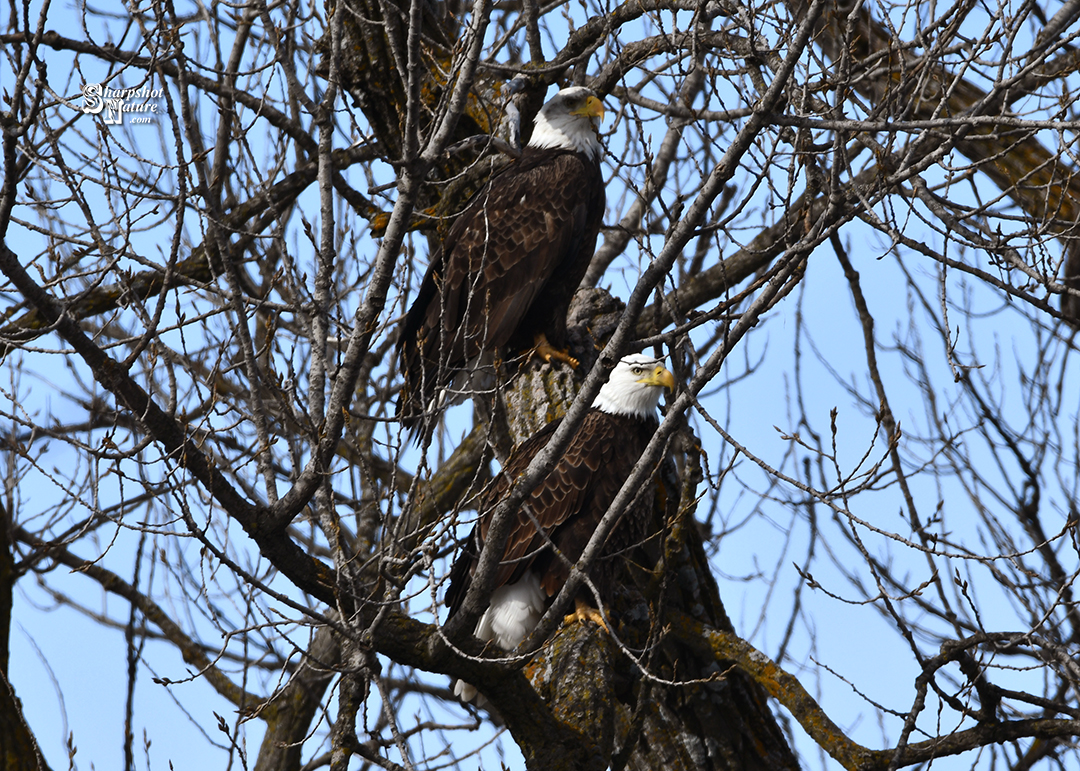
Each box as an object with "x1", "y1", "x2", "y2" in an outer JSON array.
[{"x1": 445, "y1": 408, "x2": 659, "y2": 616}]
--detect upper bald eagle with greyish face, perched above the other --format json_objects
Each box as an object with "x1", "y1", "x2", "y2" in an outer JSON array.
[{"x1": 397, "y1": 87, "x2": 604, "y2": 427}]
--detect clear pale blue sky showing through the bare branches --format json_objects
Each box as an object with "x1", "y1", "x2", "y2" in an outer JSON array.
[{"x1": 0, "y1": 0, "x2": 1080, "y2": 769}]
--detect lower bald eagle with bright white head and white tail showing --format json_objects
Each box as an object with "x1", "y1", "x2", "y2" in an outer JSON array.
[{"x1": 445, "y1": 353, "x2": 675, "y2": 701}]
